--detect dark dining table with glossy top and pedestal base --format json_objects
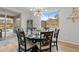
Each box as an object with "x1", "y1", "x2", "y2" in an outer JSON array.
[{"x1": 26, "y1": 30, "x2": 53, "y2": 51}]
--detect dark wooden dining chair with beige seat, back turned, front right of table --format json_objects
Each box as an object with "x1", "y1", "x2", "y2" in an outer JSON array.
[{"x1": 37, "y1": 31, "x2": 53, "y2": 52}]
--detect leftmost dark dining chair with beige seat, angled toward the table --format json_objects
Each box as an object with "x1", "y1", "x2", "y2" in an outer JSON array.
[{"x1": 17, "y1": 29, "x2": 33, "y2": 52}]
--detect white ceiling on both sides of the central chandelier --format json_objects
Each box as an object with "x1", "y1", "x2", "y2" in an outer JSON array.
[{"x1": 0, "y1": 7, "x2": 62, "y2": 16}]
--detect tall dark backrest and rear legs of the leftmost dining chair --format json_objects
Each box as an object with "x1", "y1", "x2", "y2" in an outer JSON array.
[{"x1": 17, "y1": 29, "x2": 26, "y2": 51}]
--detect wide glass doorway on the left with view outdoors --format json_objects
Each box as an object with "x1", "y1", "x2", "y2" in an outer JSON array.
[{"x1": 0, "y1": 8, "x2": 21, "y2": 40}]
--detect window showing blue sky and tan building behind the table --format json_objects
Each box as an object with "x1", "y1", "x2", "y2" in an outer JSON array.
[{"x1": 41, "y1": 11, "x2": 59, "y2": 27}]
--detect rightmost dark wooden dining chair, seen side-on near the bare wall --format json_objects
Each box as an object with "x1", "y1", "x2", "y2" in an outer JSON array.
[{"x1": 52, "y1": 28, "x2": 60, "y2": 51}]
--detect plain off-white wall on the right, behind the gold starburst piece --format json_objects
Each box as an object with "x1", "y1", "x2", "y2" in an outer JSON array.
[{"x1": 59, "y1": 8, "x2": 79, "y2": 44}]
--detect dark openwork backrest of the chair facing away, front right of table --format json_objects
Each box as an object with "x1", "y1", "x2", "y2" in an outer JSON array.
[{"x1": 40, "y1": 31, "x2": 53, "y2": 51}]
